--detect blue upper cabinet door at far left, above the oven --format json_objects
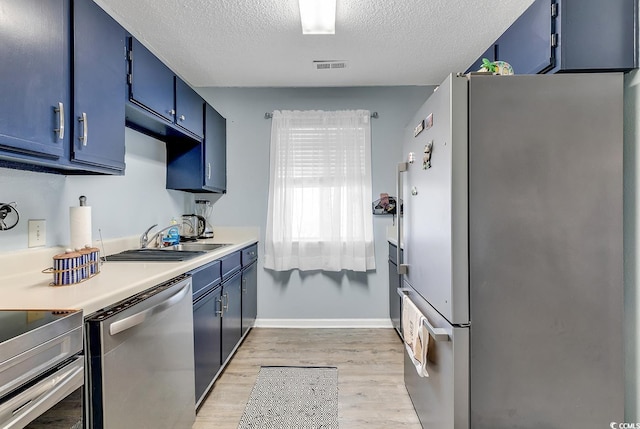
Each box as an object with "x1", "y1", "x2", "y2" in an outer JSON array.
[{"x1": 0, "y1": 0, "x2": 71, "y2": 159}]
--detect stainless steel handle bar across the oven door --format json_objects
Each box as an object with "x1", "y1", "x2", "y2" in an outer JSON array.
[{"x1": 0, "y1": 356, "x2": 84, "y2": 429}]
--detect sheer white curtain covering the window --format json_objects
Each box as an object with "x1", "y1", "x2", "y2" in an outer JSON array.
[{"x1": 264, "y1": 110, "x2": 375, "y2": 271}]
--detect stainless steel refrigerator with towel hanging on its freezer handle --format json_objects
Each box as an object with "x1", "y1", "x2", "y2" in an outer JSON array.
[{"x1": 398, "y1": 73, "x2": 624, "y2": 429}]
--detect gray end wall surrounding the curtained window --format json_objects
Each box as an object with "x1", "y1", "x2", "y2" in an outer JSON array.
[{"x1": 198, "y1": 87, "x2": 433, "y2": 319}]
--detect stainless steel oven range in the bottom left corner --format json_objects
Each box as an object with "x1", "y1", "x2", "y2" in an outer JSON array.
[{"x1": 0, "y1": 310, "x2": 84, "y2": 429}]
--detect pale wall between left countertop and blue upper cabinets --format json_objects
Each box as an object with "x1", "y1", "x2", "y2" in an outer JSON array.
[{"x1": 0, "y1": 128, "x2": 193, "y2": 249}]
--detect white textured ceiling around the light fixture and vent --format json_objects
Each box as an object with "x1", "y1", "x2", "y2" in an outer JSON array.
[{"x1": 95, "y1": 0, "x2": 533, "y2": 87}]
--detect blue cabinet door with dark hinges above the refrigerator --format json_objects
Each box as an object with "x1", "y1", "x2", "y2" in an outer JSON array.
[{"x1": 496, "y1": 0, "x2": 554, "y2": 74}]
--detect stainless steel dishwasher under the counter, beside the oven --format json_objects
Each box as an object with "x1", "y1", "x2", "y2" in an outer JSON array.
[{"x1": 86, "y1": 275, "x2": 195, "y2": 429}]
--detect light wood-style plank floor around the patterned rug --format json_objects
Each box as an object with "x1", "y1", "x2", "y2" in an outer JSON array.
[{"x1": 193, "y1": 328, "x2": 421, "y2": 429}]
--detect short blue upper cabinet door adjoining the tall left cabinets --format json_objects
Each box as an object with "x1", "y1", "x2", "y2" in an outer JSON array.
[{"x1": 129, "y1": 37, "x2": 176, "y2": 122}]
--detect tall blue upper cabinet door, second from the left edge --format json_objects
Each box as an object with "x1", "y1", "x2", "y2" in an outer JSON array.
[{"x1": 71, "y1": 0, "x2": 127, "y2": 171}]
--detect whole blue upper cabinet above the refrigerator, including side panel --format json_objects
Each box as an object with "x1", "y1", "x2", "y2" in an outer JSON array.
[{"x1": 467, "y1": 0, "x2": 638, "y2": 74}]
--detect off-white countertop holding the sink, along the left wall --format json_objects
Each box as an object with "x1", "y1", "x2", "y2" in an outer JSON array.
[{"x1": 0, "y1": 228, "x2": 259, "y2": 316}]
